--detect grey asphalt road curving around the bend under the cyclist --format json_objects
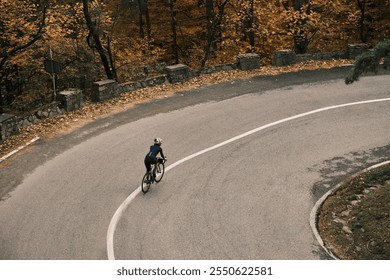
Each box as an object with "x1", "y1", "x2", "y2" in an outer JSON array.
[{"x1": 0, "y1": 66, "x2": 390, "y2": 259}]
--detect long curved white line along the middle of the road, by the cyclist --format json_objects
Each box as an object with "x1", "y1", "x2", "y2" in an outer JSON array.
[{"x1": 107, "y1": 98, "x2": 390, "y2": 260}]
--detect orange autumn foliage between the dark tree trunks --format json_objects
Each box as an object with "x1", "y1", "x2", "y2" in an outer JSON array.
[{"x1": 0, "y1": 0, "x2": 390, "y2": 112}]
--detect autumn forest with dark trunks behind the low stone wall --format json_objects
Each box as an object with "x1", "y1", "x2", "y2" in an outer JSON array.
[{"x1": 0, "y1": 0, "x2": 390, "y2": 114}]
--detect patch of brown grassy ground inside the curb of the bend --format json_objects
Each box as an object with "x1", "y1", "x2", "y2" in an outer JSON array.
[{"x1": 318, "y1": 163, "x2": 390, "y2": 260}]
